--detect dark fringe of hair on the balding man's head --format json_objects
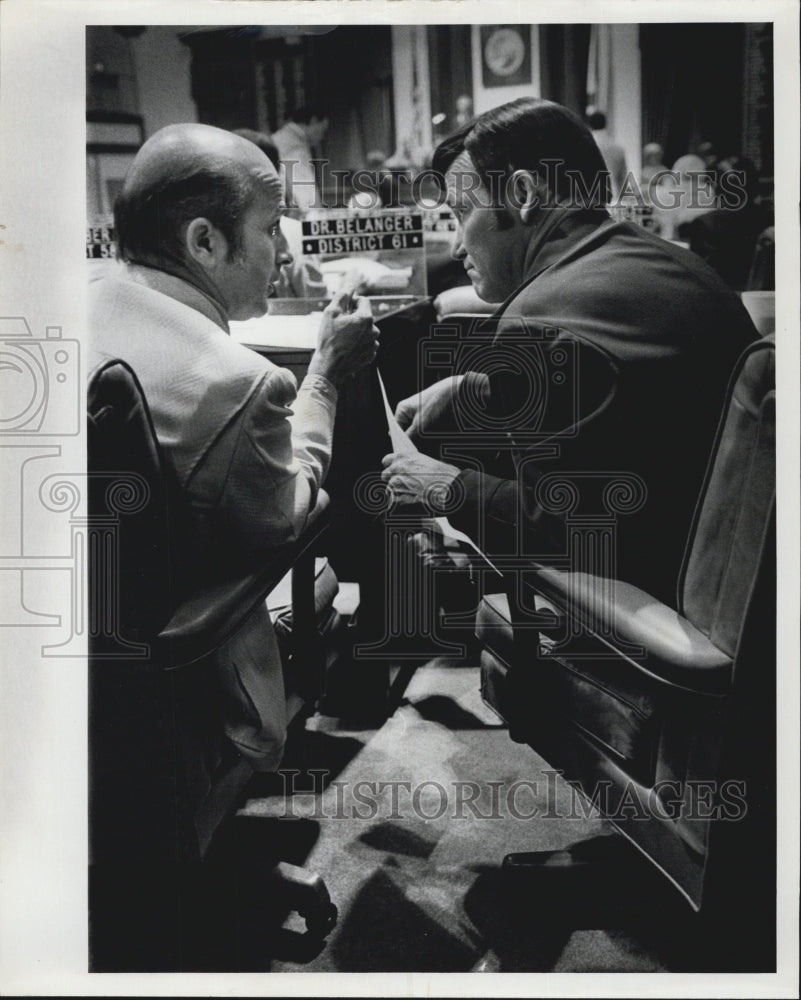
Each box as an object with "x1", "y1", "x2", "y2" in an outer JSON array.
[{"x1": 114, "y1": 167, "x2": 253, "y2": 266}]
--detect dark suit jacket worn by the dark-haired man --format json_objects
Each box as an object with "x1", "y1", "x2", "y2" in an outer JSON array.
[{"x1": 451, "y1": 211, "x2": 757, "y2": 604}]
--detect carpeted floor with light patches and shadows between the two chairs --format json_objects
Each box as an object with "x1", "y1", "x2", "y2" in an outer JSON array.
[{"x1": 220, "y1": 660, "x2": 720, "y2": 972}]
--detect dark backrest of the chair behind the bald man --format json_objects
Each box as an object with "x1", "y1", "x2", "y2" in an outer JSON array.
[{"x1": 87, "y1": 360, "x2": 203, "y2": 864}]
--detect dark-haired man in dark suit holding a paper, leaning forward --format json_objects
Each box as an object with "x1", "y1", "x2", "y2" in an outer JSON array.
[{"x1": 384, "y1": 98, "x2": 756, "y2": 602}]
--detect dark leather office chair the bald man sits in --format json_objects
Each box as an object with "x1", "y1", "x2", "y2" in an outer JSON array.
[{"x1": 87, "y1": 361, "x2": 337, "y2": 970}]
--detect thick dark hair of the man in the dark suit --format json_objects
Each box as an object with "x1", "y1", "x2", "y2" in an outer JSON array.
[{"x1": 432, "y1": 97, "x2": 610, "y2": 208}]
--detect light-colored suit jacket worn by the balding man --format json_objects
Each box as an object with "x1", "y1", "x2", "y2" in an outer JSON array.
[{"x1": 90, "y1": 265, "x2": 337, "y2": 769}]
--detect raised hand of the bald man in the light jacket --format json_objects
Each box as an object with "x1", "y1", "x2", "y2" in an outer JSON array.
[{"x1": 309, "y1": 288, "x2": 379, "y2": 388}]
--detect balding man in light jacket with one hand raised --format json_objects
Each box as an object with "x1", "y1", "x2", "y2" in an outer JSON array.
[{"x1": 90, "y1": 125, "x2": 377, "y2": 770}]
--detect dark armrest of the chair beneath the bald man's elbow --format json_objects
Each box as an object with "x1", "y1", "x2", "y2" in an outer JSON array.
[{"x1": 158, "y1": 490, "x2": 331, "y2": 666}]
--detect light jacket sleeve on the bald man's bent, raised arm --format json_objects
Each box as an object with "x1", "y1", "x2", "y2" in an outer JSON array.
[{"x1": 221, "y1": 368, "x2": 337, "y2": 551}]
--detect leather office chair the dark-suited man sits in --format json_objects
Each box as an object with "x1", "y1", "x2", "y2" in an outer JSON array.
[{"x1": 477, "y1": 339, "x2": 776, "y2": 922}]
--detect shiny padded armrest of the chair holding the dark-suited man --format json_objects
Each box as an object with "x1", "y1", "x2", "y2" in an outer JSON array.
[{"x1": 529, "y1": 567, "x2": 733, "y2": 694}]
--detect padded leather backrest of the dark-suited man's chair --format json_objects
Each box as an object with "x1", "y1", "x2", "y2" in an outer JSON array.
[{"x1": 679, "y1": 338, "x2": 776, "y2": 656}]
